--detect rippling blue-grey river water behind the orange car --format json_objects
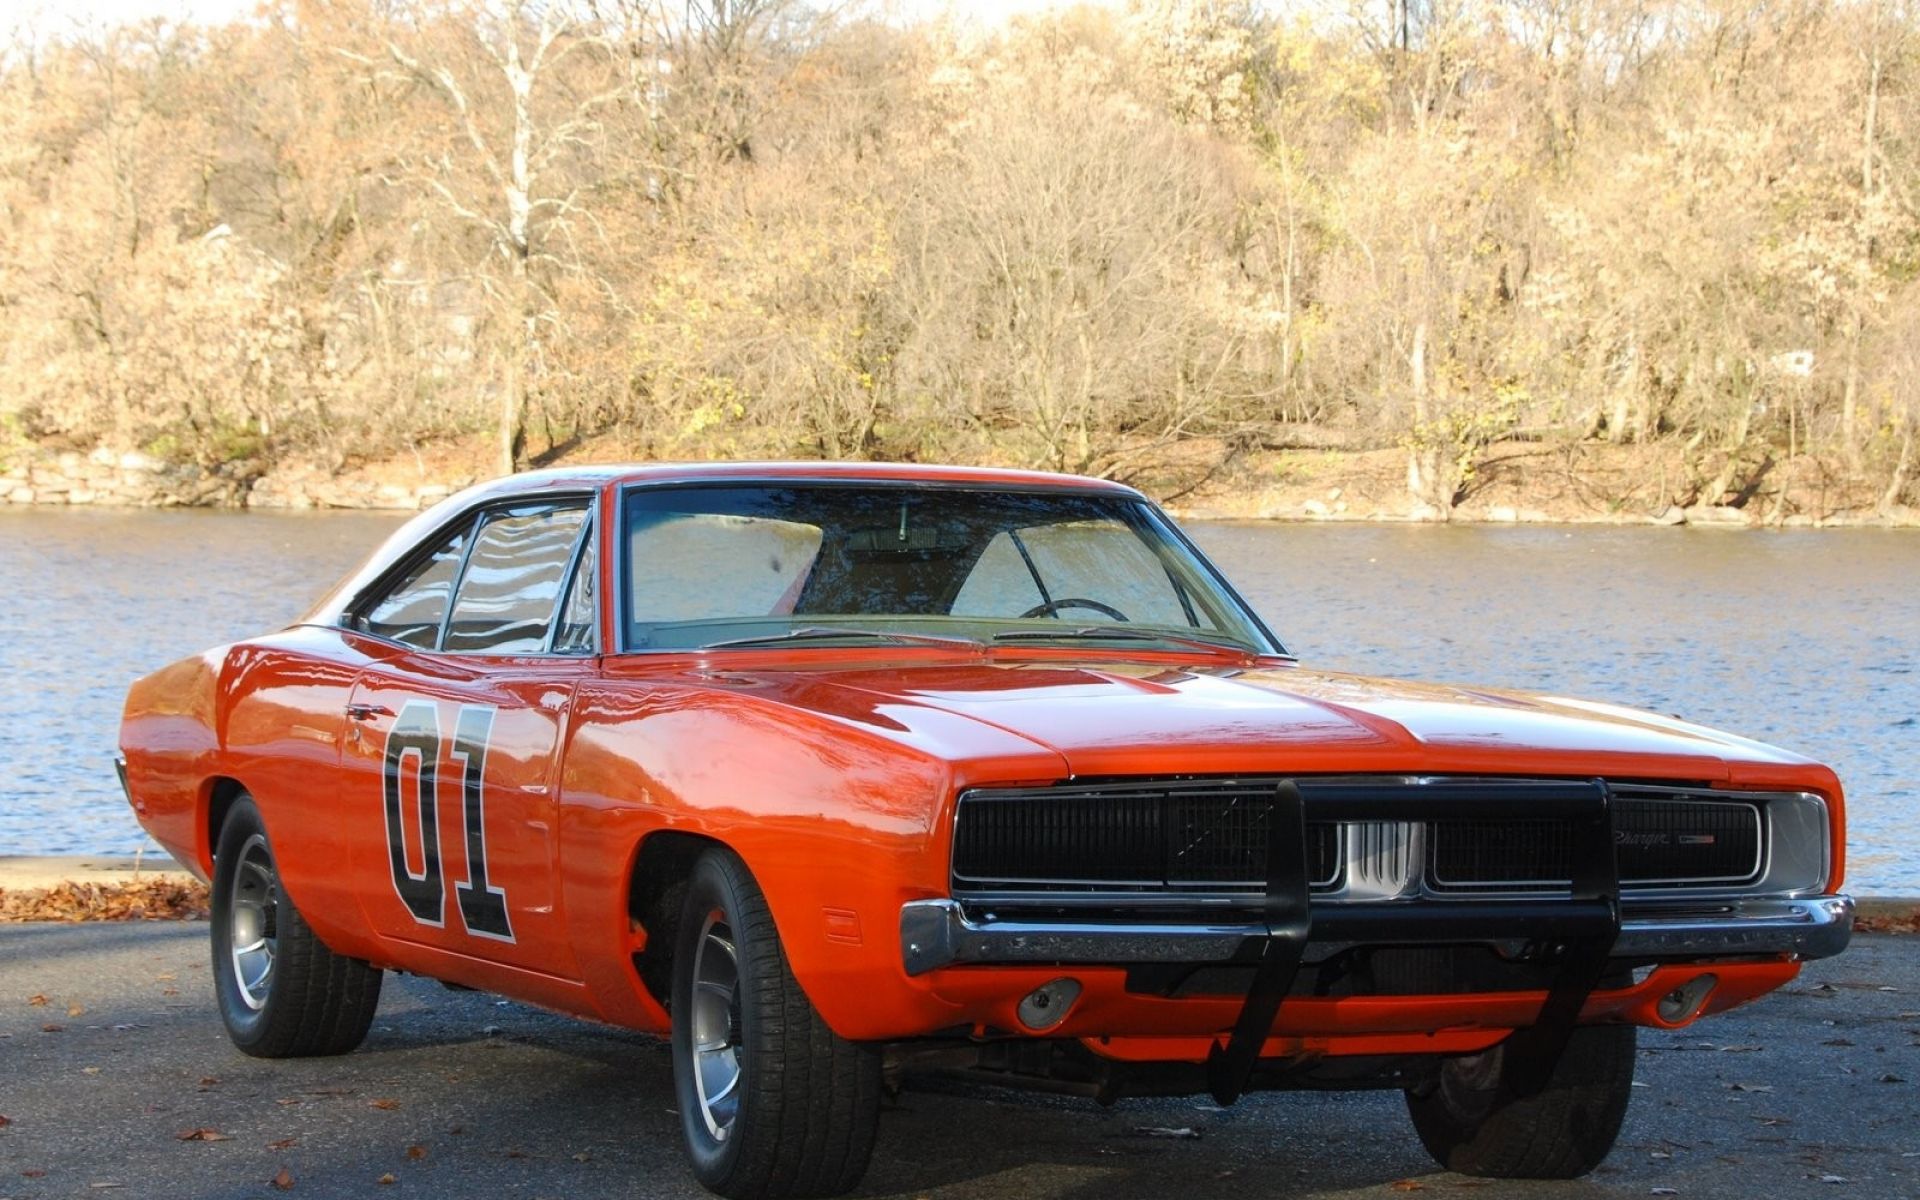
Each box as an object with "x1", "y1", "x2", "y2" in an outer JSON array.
[{"x1": 0, "y1": 509, "x2": 1920, "y2": 895}]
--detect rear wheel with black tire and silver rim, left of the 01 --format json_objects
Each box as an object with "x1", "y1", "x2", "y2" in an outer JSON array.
[{"x1": 211, "y1": 795, "x2": 380, "y2": 1058}]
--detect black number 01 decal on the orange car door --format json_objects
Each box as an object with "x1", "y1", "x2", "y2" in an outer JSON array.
[{"x1": 380, "y1": 701, "x2": 513, "y2": 941}]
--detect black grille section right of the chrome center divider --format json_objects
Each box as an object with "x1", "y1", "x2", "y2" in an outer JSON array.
[{"x1": 1428, "y1": 797, "x2": 1761, "y2": 891}]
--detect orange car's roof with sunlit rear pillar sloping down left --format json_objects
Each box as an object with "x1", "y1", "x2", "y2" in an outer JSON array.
[{"x1": 301, "y1": 463, "x2": 1140, "y2": 624}]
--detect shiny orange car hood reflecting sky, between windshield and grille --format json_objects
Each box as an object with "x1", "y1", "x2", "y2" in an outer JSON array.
[{"x1": 683, "y1": 660, "x2": 1822, "y2": 781}]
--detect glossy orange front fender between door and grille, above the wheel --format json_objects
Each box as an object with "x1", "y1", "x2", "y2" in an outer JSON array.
[{"x1": 561, "y1": 684, "x2": 1064, "y2": 1039}]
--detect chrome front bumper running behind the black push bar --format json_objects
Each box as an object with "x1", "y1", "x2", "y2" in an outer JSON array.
[{"x1": 900, "y1": 895, "x2": 1853, "y2": 975}]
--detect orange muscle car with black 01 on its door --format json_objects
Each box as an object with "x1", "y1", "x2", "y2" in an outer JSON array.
[{"x1": 121, "y1": 463, "x2": 1853, "y2": 1196}]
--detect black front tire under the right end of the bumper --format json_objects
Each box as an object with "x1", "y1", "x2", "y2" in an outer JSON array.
[{"x1": 1407, "y1": 1025, "x2": 1636, "y2": 1179}]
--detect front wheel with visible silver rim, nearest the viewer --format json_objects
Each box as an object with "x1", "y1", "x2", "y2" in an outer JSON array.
[{"x1": 672, "y1": 849, "x2": 879, "y2": 1198}]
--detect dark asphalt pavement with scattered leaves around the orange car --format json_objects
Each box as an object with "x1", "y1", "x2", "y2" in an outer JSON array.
[{"x1": 0, "y1": 924, "x2": 1920, "y2": 1200}]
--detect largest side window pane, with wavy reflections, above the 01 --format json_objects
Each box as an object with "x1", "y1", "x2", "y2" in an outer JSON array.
[{"x1": 442, "y1": 505, "x2": 586, "y2": 655}]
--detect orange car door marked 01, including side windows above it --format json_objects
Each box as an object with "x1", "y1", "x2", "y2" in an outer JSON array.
[{"x1": 342, "y1": 497, "x2": 595, "y2": 979}]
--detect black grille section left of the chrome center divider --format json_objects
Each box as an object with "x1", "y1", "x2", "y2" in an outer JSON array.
[{"x1": 954, "y1": 785, "x2": 1340, "y2": 891}]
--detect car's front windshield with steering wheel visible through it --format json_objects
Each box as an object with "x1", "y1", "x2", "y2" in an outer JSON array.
[{"x1": 622, "y1": 482, "x2": 1279, "y2": 653}]
